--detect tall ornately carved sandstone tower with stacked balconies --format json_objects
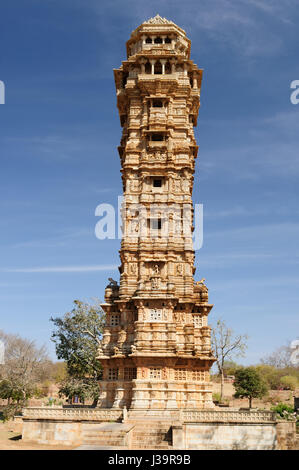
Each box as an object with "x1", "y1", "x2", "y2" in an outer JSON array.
[{"x1": 98, "y1": 15, "x2": 214, "y2": 409}]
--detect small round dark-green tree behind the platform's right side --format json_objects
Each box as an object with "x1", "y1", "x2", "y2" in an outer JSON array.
[{"x1": 234, "y1": 367, "x2": 268, "y2": 408}]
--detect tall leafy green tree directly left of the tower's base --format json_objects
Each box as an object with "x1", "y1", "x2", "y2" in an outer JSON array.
[{"x1": 51, "y1": 300, "x2": 105, "y2": 404}]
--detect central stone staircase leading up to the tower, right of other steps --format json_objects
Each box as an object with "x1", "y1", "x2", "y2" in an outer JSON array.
[{"x1": 131, "y1": 421, "x2": 172, "y2": 449}]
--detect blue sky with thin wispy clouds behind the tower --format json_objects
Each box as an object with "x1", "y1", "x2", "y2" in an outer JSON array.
[{"x1": 0, "y1": 0, "x2": 299, "y2": 363}]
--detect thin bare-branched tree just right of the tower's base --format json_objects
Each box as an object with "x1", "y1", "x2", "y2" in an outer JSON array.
[{"x1": 211, "y1": 320, "x2": 248, "y2": 400}]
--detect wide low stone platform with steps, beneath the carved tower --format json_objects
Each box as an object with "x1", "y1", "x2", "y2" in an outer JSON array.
[{"x1": 22, "y1": 407, "x2": 296, "y2": 450}]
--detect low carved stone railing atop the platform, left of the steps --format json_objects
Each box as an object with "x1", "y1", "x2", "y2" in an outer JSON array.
[{"x1": 22, "y1": 406, "x2": 123, "y2": 421}]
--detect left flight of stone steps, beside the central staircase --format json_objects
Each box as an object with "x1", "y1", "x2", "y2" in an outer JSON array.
[{"x1": 82, "y1": 423, "x2": 133, "y2": 448}]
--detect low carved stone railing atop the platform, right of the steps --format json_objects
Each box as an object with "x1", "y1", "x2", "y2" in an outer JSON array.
[{"x1": 180, "y1": 410, "x2": 276, "y2": 423}]
